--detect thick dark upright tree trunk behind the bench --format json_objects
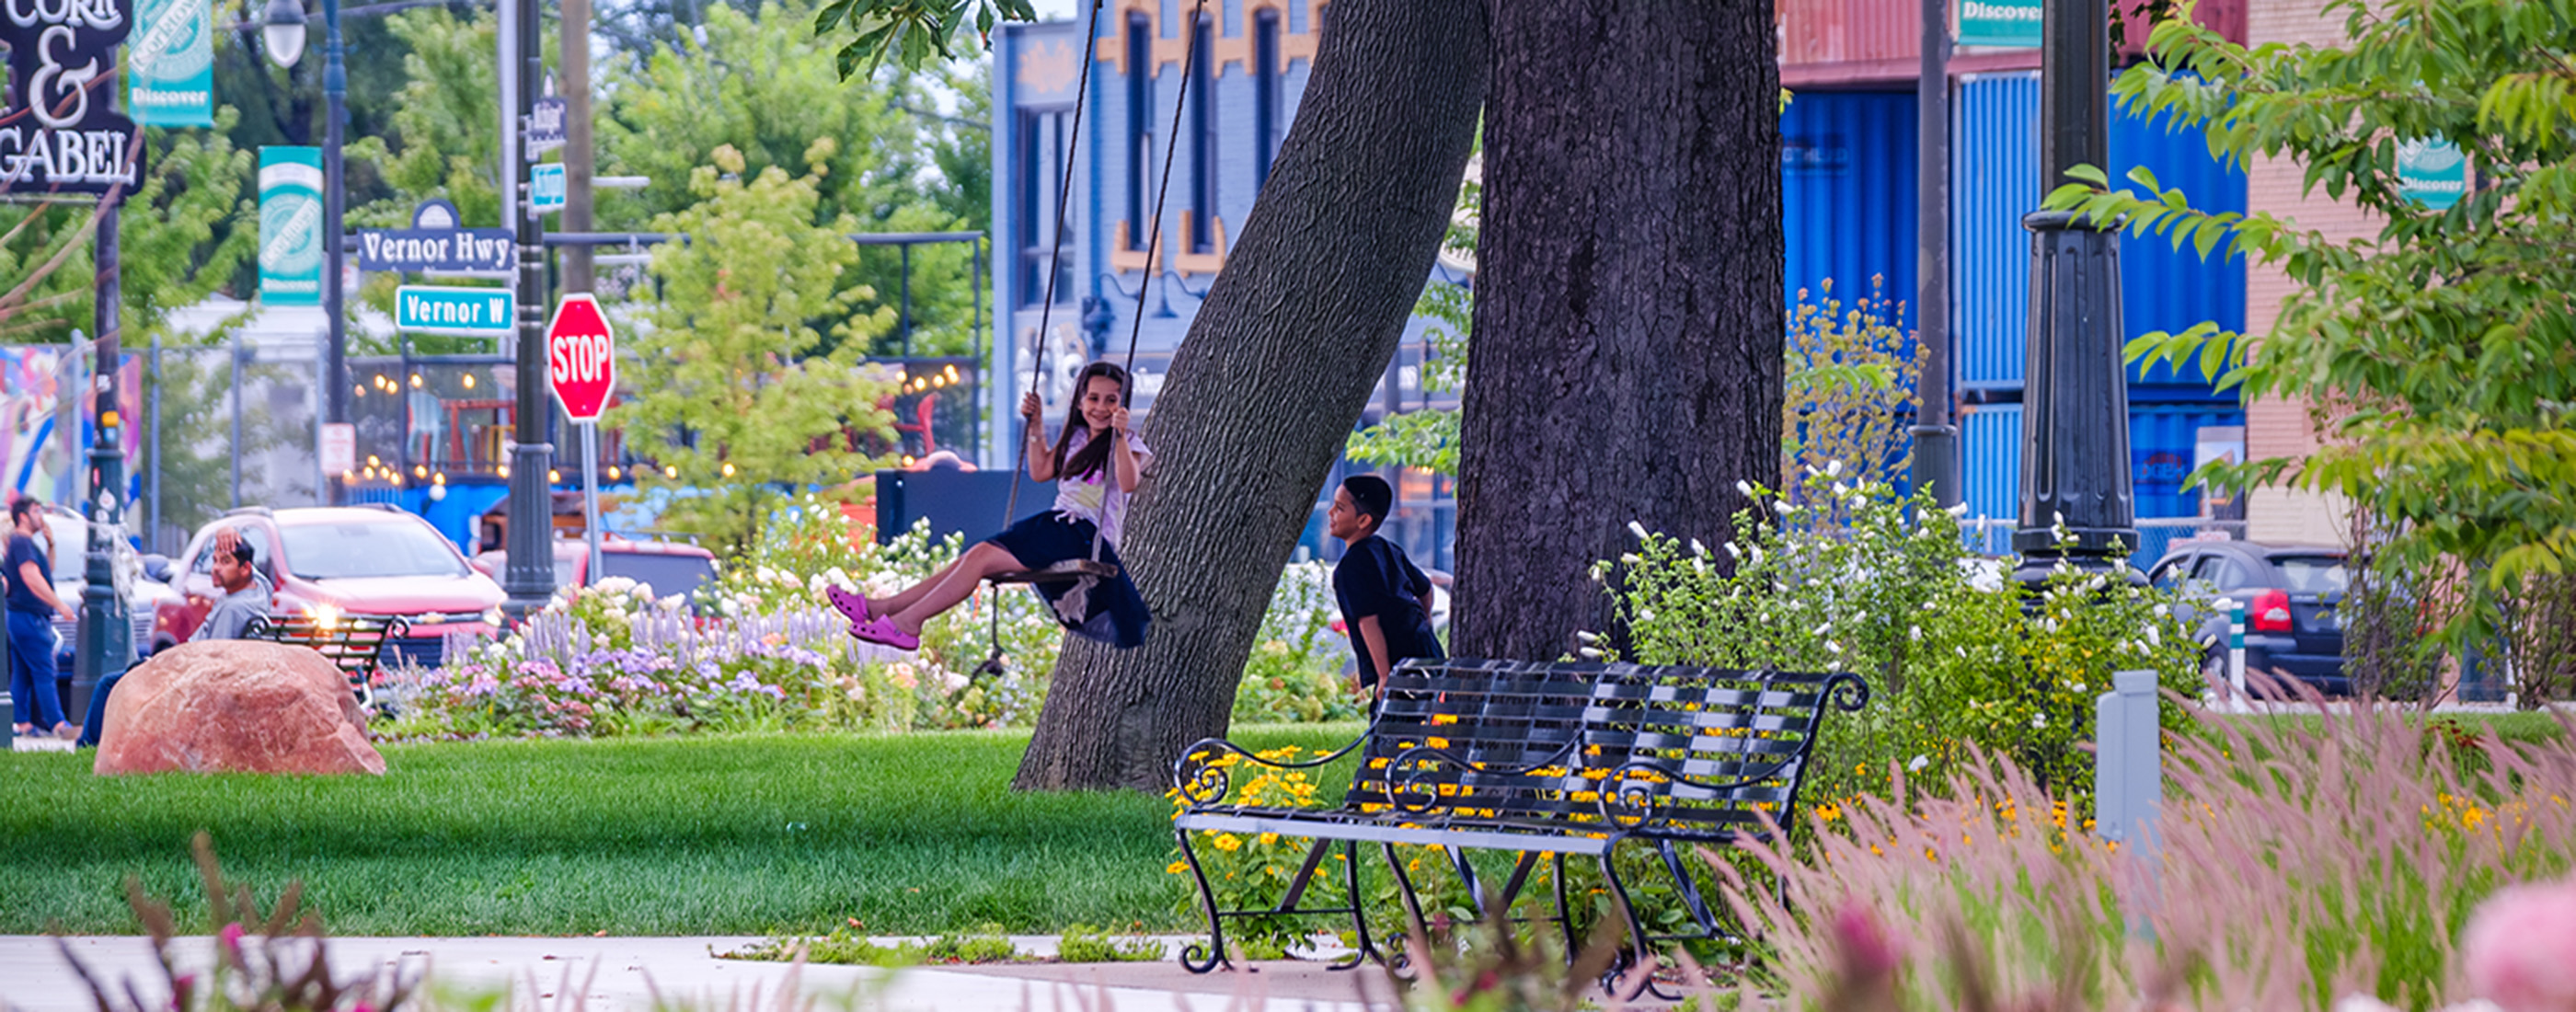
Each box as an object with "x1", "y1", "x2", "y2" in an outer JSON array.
[{"x1": 1453, "y1": 0, "x2": 1783, "y2": 660}]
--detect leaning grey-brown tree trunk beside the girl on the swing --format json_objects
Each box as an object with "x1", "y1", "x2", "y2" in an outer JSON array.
[{"x1": 1012, "y1": 0, "x2": 1494, "y2": 790}]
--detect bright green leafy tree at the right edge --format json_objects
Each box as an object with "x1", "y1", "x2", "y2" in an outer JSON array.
[{"x1": 2051, "y1": 0, "x2": 2576, "y2": 644}]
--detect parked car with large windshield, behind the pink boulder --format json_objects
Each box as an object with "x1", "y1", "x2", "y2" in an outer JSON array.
[{"x1": 152, "y1": 505, "x2": 505, "y2": 667}]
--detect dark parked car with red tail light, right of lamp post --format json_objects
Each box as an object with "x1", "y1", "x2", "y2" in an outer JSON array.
[{"x1": 2148, "y1": 541, "x2": 2352, "y2": 696}]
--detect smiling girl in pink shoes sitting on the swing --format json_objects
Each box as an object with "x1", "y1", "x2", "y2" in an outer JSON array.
[{"x1": 824, "y1": 363, "x2": 1154, "y2": 649}]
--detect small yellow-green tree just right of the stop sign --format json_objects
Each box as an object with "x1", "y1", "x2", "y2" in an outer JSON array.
[{"x1": 605, "y1": 136, "x2": 896, "y2": 554}]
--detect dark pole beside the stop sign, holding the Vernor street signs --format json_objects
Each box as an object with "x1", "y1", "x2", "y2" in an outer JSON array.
[{"x1": 500, "y1": 0, "x2": 554, "y2": 615}]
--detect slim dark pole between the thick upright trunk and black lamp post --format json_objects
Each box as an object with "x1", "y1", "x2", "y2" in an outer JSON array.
[{"x1": 1912, "y1": 0, "x2": 1961, "y2": 507}]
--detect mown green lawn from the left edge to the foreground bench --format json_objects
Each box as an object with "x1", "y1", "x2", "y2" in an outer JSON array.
[{"x1": 0, "y1": 724, "x2": 1358, "y2": 935}]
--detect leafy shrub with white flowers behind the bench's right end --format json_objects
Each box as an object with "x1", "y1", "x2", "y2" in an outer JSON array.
[{"x1": 1592, "y1": 461, "x2": 2200, "y2": 811}]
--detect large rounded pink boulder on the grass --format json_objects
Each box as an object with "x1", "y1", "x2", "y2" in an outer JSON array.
[{"x1": 93, "y1": 638, "x2": 384, "y2": 775}]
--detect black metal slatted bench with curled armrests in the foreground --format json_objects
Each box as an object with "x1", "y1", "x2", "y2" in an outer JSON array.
[{"x1": 1172, "y1": 660, "x2": 1868, "y2": 973}]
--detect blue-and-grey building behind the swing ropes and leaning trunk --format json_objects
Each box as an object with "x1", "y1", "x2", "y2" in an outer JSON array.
[{"x1": 982, "y1": 0, "x2": 1466, "y2": 569}]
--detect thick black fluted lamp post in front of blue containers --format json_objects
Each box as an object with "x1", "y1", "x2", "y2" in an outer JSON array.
[{"x1": 2012, "y1": 0, "x2": 2138, "y2": 582}]
